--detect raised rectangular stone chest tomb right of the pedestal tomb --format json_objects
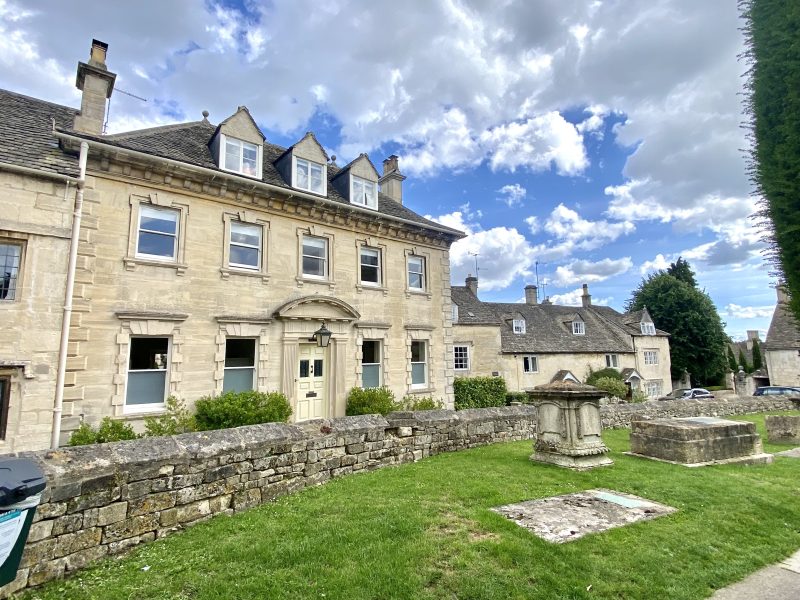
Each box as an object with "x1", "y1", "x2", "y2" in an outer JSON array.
[{"x1": 628, "y1": 417, "x2": 772, "y2": 467}]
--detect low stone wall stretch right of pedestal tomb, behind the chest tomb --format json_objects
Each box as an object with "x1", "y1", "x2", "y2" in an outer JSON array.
[{"x1": 600, "y1": 396, "x2": 800, "y2": 428}]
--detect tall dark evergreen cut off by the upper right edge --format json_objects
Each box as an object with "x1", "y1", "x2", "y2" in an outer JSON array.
[{"x1": 739, "y1": 0, "x2": 800, "y2": 319}]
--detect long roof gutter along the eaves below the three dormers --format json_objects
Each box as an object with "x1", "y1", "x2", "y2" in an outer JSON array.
[{"x1": 53, "y1": 128, "x2": 466, "y2": 239}]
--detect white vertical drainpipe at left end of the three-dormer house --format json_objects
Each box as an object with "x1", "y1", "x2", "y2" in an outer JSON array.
[{"x1": 50, "y1": 142, "x2": 89, "y2": 450}]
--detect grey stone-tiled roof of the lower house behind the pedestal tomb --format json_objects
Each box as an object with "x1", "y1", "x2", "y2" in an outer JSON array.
[{"x1": 451, "y1": 286, "x2": 668, "y2": 354}]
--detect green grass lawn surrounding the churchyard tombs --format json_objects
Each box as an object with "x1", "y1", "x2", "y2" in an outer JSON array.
[{"x1": 18, "y1": 412, "x2": 800, "y2": 600}]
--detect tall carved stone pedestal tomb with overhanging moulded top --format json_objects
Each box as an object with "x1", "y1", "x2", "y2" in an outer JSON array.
[{"x1": 528, "y1": 381, "x2": 613, "y2": 469}]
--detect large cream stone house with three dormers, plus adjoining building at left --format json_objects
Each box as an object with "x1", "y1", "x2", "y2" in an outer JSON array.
[{"x1": 0, "y1": 40, "x2": 463, "y2": 452}]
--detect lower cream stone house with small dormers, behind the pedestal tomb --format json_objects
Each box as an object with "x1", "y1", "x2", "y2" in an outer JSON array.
[{"x1": 452, "y1": 276, "x2": 672, "y2": 398}]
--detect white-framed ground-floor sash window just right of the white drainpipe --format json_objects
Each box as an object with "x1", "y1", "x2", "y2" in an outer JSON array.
[{"x1": 125, "y1": 337, "x2": 169, "y2": 410}]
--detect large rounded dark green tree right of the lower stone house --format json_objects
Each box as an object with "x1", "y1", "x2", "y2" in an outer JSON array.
[{"x1": 626, "y1": 261, "x2": 728, "y2": 385}]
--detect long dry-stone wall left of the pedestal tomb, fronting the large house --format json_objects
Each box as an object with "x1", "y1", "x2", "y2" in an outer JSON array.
[{"x1": 0, "y1": 406, "x2": 536, "y2": 598}]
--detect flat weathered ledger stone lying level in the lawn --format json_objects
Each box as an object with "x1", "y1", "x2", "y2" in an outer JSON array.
[{"x1": 491, "y1": 489, "x2": 677, "y2": 544}]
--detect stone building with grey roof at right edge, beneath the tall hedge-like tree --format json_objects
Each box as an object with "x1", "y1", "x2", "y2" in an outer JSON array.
[{"x1": 762, "y1": 287, "x2": 800, "y2": 386}]
